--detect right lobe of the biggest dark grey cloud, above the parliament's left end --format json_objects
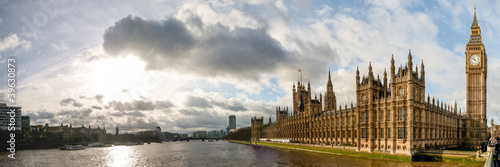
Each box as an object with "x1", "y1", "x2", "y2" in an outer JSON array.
[{"x1": 191, "y1": 23, "x2": 286, "y2": 79}]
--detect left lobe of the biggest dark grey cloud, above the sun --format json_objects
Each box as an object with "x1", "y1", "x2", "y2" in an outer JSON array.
[{"x1": 103, "y1": 15, "x2": 195, "y2": 63}]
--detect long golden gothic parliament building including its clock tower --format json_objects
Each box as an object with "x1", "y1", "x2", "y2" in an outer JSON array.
[{"x1": 251, "y1": 7, "x2": 488, "y2": 154}]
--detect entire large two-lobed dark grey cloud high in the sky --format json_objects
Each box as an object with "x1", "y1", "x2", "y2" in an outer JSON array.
[{"x1": 103, "y1": 16, "x2": 300, "y2": 80}]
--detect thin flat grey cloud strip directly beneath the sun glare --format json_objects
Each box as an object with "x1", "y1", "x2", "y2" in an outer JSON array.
[{"x1": 108, "y1": 99, "x2": 174, "y2": 111}]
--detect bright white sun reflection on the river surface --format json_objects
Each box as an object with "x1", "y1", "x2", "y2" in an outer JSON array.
[{"x1": 106, "y1": 146, "x2": 138, "y2": 166}]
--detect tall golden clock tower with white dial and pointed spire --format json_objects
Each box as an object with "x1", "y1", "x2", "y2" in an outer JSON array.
[{"x1": 465, "y1": 6, "x2": 488, "y2": 146}]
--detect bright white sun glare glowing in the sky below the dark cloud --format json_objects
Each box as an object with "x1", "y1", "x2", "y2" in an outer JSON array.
[{"x1": 89, "y1": 56, "x2": 146, "y2": 99}]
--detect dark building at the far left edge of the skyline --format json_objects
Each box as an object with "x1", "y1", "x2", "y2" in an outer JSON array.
[{"x1": 0, "y1": 103, "x2": 21, "y2": 131}]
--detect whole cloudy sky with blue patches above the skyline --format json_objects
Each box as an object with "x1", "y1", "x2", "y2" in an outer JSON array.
[{"x1": 0, "y1": 0, "x2": 500, "y2": 133}]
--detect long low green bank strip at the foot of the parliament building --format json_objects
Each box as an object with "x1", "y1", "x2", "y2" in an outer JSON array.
[{"x1": 230, "y1": 140, "x2": 485, "y2": 166}]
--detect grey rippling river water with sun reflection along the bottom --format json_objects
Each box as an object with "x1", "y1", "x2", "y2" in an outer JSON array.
[{"x1": 0, "y1": 141, "x2": 481, "y2": 167}]
